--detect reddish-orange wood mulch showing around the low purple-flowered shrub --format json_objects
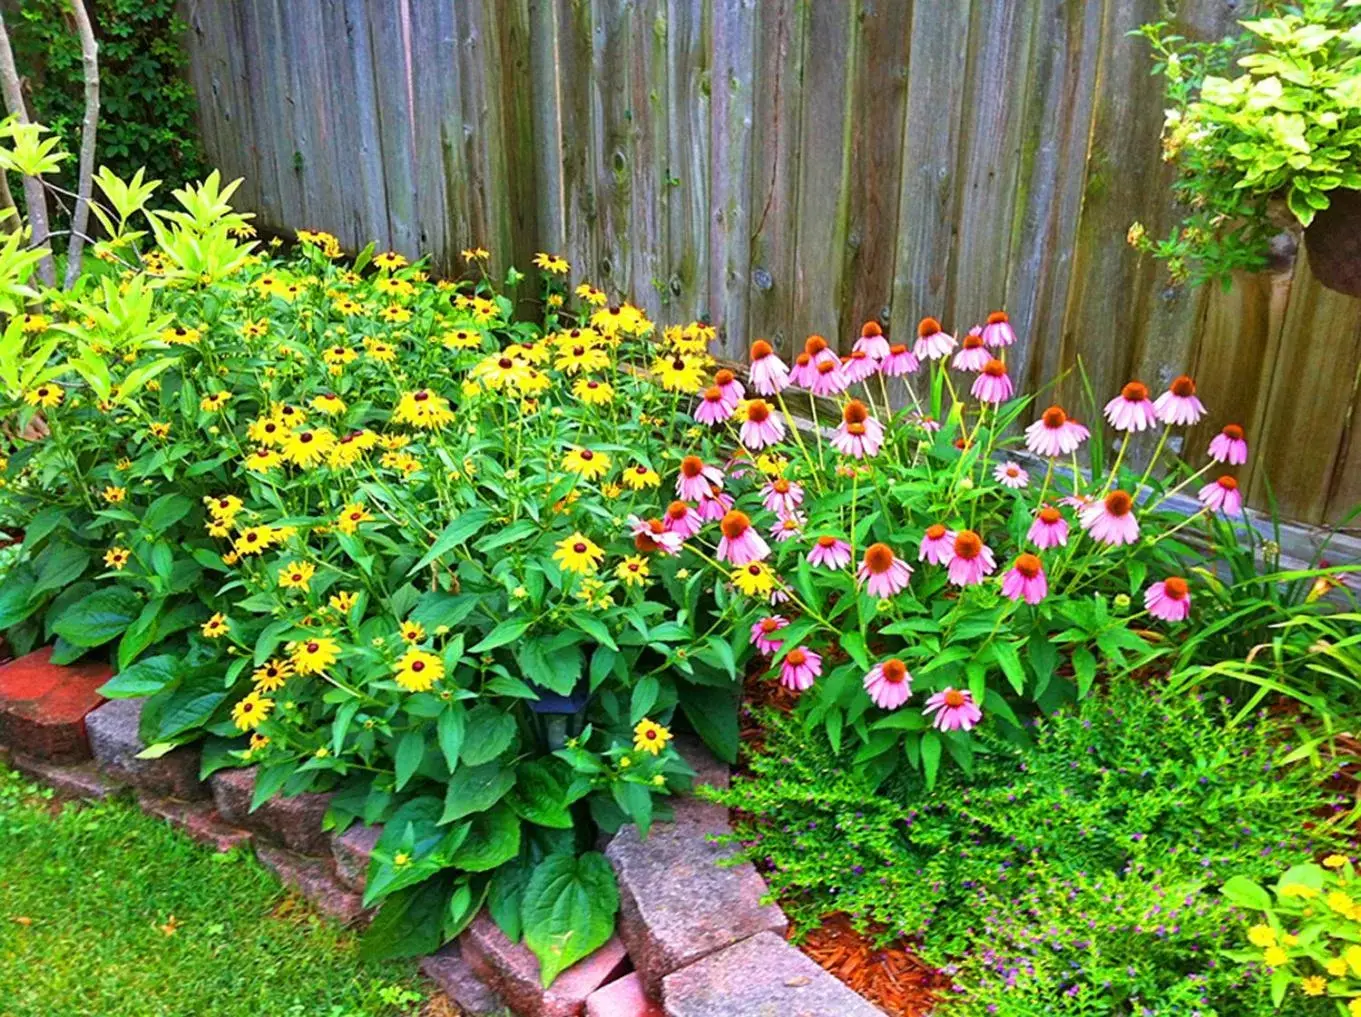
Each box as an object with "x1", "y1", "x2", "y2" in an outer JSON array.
[{"x1": 739, "y1": 668, "x2": 950, "y2": 1017}]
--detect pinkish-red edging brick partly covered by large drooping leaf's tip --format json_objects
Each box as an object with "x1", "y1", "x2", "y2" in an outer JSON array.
[{"x1": 459, "y1": 912, "x2": 629, "y2": 1017}]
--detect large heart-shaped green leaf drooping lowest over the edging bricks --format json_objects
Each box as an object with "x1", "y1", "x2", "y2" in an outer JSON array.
[{"x1": 521, "y1": 851, "x2": 619, "y2": 986}]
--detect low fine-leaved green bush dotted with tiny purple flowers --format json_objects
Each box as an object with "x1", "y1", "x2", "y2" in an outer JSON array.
[{"x1": 719, "y1": 678, "x2": 1341, "y2": 1017}]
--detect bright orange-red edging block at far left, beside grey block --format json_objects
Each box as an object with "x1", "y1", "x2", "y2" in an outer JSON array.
[{"x1": 0, "y1": 649, "x2": 113, "y2": 762}]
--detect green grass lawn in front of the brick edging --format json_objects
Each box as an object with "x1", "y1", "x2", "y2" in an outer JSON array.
[{"x1": 0, "y1": 766, "x2": 422, "y2": 1017}]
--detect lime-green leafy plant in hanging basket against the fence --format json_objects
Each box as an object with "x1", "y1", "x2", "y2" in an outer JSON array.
[{"x1": 1128, "y1": 0, "x2": 1361, "y2": 295}]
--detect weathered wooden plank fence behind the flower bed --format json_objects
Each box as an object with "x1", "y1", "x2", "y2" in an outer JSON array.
[{"x1": 184, "y1": 0, "x2": 1361, "y2": 523}]
